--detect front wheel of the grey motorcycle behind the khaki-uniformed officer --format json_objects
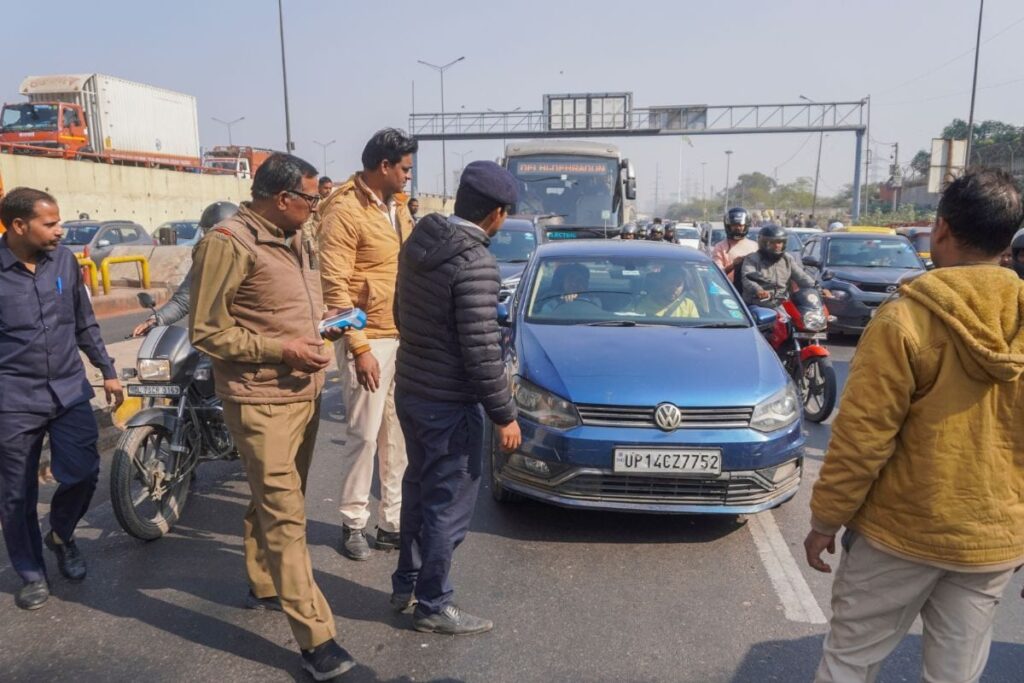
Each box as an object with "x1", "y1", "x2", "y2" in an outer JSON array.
[{"x1": 111, "y1": 425, "x2": 194, "y2": 541}]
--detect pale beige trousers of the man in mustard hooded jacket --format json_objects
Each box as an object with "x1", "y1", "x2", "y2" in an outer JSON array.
[{"x1": 814, "y1": 535, "x2": 1013, "y2": 683}]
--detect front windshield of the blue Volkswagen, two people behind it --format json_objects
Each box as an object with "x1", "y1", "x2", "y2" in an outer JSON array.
[{"x1": 525, "y1": 256, "x2": 750, "y2": 328}]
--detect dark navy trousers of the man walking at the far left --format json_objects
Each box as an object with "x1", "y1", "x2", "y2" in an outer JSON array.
[{"x1": 0, "y1": 401, "x2": 99, "y2": 582}]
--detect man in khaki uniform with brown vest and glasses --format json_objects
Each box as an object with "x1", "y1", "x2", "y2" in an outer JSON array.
[{"x1": 190, "y1": 154, "x2": 354, "y2": 680}]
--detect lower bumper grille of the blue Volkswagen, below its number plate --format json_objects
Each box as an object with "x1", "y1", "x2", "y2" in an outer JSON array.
[{"x1": 557, "y1": 473, "x2": 786, "y2": 505}]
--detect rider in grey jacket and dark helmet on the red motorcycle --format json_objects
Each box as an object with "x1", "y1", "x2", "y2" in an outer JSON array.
[{"x1": 740, "y1": 224, "x2": 829, "y2": 308}]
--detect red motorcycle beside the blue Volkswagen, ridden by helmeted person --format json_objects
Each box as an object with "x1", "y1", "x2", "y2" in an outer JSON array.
[{"x1": 768, "y1": 289, "x2": 838, "y2": 422}]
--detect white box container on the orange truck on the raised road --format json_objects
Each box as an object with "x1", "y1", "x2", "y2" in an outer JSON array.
[{"x1": 20, "y1": 74, "x2": 200, "y2": 167}]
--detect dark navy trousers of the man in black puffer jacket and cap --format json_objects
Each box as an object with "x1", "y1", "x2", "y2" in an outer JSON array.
[{"x1": 391, "y1": 390, "x2": 484, "y2": 614}]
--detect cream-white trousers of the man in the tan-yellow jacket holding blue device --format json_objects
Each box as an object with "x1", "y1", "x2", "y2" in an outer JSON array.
[{"x1": 335, "y1": 339, "x2": 408, "y2": 531}]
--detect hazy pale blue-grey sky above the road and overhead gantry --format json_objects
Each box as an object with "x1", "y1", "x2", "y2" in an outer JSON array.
[{"x1": 0, "y1": 0, "x2": 1024, "y2": 214}]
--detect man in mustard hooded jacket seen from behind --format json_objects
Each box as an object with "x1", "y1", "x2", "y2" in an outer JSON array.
[{"x1": 804, "y1": 170, "x2": 1024, "y2": 682}]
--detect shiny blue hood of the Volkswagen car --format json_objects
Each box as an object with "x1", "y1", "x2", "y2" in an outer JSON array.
[{"x1": 516, "y1": 324, "x2": 787, "y2": 408}]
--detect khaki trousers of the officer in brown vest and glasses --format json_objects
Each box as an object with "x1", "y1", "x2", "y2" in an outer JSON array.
[{"x1": 224, "y1": 400, "x2": 336, "y2": 650}]
